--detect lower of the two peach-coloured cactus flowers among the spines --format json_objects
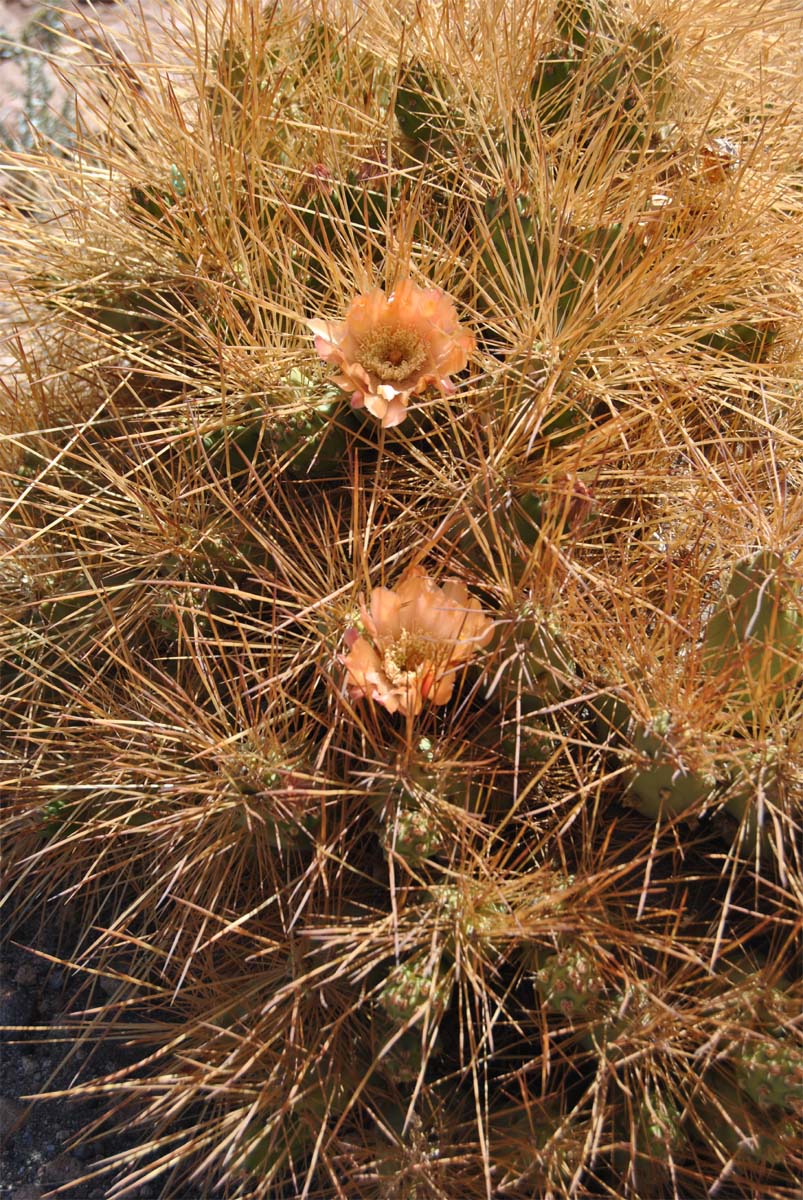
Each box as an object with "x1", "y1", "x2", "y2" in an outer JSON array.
[{"x1": 343, "y1": 566, "x2": 493, "y2": 716}]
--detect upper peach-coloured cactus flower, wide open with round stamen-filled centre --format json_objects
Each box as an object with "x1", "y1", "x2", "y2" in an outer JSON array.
[{"x1": 307, "y1": 280, "x2": 474, "y2": 427}]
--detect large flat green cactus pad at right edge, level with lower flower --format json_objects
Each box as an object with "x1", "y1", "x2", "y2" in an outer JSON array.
[{"x1": 702, "y1": 550, "x2": 803, "y2": 725}]
